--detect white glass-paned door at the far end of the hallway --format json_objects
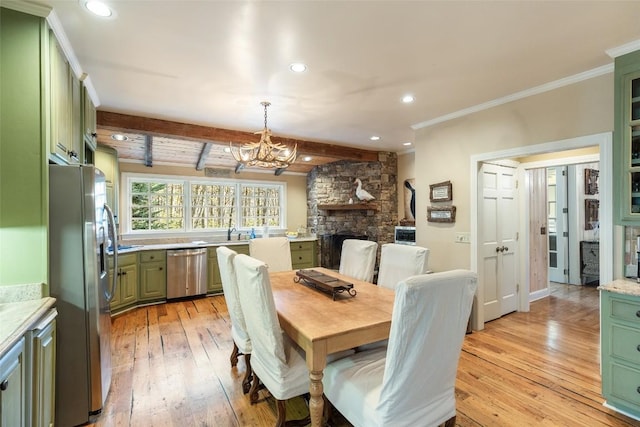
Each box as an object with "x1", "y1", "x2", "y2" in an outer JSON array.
[{"x1": 547, "y1": 166, "x2": 569, "y2": 283}]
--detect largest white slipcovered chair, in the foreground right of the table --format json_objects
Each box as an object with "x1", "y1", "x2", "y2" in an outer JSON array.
[{"x1": 323, "y1": 270, "x2": 477, "y2": 427}]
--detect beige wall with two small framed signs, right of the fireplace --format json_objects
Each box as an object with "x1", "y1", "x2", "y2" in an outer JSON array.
[{"x1": 415, "y1": 74, "x2": 613, "y2": 271}]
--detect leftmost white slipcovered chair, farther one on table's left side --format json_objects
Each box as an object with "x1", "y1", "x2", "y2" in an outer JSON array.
[{"x1": 216, "y1": 246, "x2": 252, "y2": 393}]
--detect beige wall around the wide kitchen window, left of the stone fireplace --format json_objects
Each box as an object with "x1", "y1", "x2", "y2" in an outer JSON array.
[{"x1": 119, "y1": 162, "x2": 307, "y2": 231}]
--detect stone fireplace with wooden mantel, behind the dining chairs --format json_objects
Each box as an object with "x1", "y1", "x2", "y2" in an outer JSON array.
[{"x1": 307, "y1": 152, "x2": 398, "y2": 268}]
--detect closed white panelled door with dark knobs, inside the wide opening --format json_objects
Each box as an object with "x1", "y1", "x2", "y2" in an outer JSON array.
[{"x1": 478, "y1": 164, "x2": 518, "y2": 322}]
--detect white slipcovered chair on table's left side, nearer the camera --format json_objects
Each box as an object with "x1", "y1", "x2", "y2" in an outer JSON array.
[{"x1": 234, "y1": 254, "x2": 309, "y2": 427}]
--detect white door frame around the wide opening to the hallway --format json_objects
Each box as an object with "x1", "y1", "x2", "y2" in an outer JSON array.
[{"x1": 469, "y1": 132, "x2": 613, "y2": 330}]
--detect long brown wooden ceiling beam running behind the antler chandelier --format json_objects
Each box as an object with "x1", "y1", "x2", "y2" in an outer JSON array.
[{"x1": 97, "y1": 111, "x2": 378, "y2": 162}]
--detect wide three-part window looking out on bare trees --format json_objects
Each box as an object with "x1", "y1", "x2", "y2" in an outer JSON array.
[{"x1": 125, "y1": 174, "x2": 286, "y2": 233}]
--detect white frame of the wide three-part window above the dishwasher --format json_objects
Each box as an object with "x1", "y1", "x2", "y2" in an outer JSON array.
[{"x1": 120, "y1": 172, "x2": 287, "y2": 238}]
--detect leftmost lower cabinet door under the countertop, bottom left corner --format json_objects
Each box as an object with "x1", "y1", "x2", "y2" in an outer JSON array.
[{"x1": 0, "y1": 337, "x2": 27, "y2": 427}]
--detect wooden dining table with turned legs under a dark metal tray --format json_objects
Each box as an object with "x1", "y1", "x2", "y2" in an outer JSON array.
[{"x1": 269, "y1": 267, "x2": 394, "y2": 427}]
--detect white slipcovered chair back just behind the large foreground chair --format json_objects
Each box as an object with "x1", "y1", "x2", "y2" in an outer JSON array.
[{"x1": 378, "y1": 243, "x2": 429, "y2": 289}]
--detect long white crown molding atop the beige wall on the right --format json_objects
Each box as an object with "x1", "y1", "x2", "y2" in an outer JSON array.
[{"x1": 411, "y1": 63, "x2": 613, "y2": 130}]
